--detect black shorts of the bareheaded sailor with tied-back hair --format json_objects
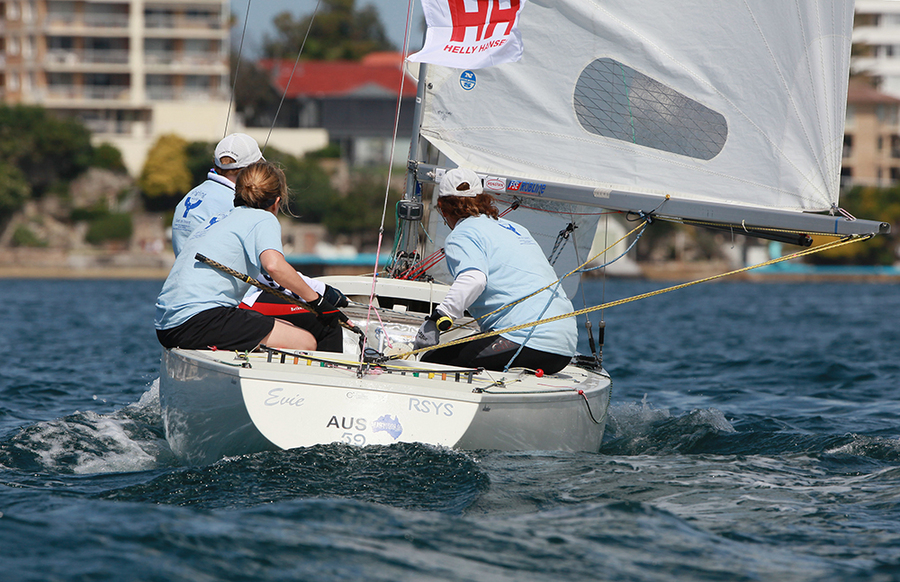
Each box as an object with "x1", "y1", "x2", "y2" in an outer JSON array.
[{"x1": 156, "y1": 307, "x2": 275, "y2": 351}]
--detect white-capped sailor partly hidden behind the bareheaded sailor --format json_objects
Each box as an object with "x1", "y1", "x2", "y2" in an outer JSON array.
[{"x1": 172, "y1": 133, "x2": 264, "y2": 257}]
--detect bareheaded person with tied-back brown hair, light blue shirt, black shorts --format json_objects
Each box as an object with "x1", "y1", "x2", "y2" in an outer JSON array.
[{"x1": 155, "y1": 161, "x2": 341, "y2": 350}]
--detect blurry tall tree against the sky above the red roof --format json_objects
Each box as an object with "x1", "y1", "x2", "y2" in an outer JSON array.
[{"x1": 263, "y1": 0, "x2": 397, "y2": 60}]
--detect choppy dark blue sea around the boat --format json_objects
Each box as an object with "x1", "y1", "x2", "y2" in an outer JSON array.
[{"x1": 0, "y1": 279, "x2": 900, "y2": 582}]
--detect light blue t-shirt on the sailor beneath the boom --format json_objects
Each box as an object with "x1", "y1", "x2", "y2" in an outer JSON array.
[{"x1": 444, "y1": 215, "x2": 578, "y2": 356}]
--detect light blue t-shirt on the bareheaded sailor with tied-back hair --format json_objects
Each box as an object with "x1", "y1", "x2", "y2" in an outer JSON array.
[{"x1": 154, "y1": 206, "x2": 284, "y2": 329}]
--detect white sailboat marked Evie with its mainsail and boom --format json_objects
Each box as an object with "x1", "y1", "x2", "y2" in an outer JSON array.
[{"x1": 160, "y1": 0, "x2": 889, "y2": 463}]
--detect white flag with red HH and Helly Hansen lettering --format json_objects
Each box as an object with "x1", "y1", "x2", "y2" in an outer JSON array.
[{"x1": 407, "y1": 0, "x2": 526, "y2": 69}]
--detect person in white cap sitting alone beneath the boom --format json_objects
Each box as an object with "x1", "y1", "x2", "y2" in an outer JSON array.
[{"x1": 415, "y1": 168, "x2": 578, "y2": 374}]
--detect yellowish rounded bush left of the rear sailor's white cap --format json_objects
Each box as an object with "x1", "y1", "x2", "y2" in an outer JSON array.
[{"x1": 138, "y1": 134, "x2": 193, "y2": 207}]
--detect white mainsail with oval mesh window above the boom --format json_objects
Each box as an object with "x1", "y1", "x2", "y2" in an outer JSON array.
[{"x1": 420, "y1": 0, "x2": 885, "y2": 233}]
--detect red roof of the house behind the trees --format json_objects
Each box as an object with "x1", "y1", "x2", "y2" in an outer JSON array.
[{"x1": 258, "y1": 53, "x2": 416, "y2": 98}]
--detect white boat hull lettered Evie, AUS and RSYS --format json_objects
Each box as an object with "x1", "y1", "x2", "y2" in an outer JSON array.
[{"x1": 160, "y1": 279, "x2": 611, "y2": 464}]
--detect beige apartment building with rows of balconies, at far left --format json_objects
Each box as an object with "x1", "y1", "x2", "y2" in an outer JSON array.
[{"x1": 0, "y1": 0, "x2": 327, "y2": 175}]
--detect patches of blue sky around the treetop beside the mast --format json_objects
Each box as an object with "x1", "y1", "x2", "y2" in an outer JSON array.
[{"x1": 231, "y1": 0, "x2": 422, "y2": 57}]
